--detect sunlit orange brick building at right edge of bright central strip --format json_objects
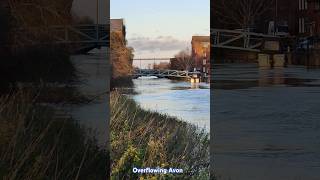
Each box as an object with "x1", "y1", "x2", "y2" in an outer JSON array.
[{"x1": 191, "y1": 36, "x2": 210, "y2": 75}]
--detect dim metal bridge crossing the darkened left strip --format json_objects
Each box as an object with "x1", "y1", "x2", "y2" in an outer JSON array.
[{"x1": 16, "y1": 24, "x2": 110, "y2": 53}]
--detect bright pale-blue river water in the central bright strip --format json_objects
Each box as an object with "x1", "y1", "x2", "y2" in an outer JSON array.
[{"x1": 133, "y1": 77, "x2": 210, "y2": 132}]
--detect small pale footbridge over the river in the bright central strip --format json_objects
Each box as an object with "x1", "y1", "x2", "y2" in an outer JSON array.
[{"x1": 133, "y1": 69, "x2": 201, "y2": 79}]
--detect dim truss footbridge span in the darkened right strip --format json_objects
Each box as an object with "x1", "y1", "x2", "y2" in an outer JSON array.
[{"x1": 211, "y1": 29, "x2": 279, "y2": 52}]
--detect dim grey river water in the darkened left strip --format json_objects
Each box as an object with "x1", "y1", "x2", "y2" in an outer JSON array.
[{"x1": 70, "y1": 48, "x2": 110, "y2": 147}]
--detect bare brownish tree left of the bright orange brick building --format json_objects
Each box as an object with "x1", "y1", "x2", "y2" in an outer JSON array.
[{"x1": 170, "y1": 49, "x2": 195, "y2": 71}]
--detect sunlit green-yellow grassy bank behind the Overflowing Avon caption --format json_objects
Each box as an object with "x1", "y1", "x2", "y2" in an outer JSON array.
[{"x1": 110, "y1": 92, "x2": 209, "y2": 179}]
